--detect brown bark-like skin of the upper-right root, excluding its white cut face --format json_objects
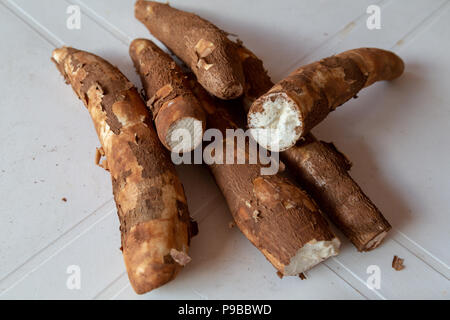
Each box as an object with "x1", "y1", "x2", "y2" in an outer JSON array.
[{"x1": 249, "y1": 48, "x2": 404, "y2": 136}]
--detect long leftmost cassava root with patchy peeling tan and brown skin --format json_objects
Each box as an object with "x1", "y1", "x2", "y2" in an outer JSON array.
[{"x1": 52, "y1": 47, "x2": 190, "y2": 294}]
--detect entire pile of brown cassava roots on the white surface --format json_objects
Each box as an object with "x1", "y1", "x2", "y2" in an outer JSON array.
[{"x1": 52, "y1": 0, "x2": 404, "y2": 294}]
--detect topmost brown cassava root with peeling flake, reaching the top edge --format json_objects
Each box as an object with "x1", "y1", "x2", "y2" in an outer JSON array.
[{"x1": 135, "y1": 0, "x2": 245, "y2": 99}]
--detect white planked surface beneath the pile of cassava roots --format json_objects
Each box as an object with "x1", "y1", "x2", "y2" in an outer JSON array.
[{"x1": 0, "y1": 0, "x2": 450, "y2": 299}]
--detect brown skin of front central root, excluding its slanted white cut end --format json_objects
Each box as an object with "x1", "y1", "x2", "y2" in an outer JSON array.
[{"x1": 188, "y1": 81, "x2": 336, "y2": 274}]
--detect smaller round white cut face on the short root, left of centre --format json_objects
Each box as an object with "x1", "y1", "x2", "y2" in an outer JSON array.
[{"x1": 166, "y1": 117, "x2": 203, "y2": 152}]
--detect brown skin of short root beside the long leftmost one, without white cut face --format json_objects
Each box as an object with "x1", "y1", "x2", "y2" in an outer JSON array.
[{"x1": 130, "y1": 39, "x2": 206, "y2": 152}]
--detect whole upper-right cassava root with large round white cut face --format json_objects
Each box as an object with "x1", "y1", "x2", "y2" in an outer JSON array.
[{"x1": 248, "y1": 48, "x2": 404, "y2": 151}]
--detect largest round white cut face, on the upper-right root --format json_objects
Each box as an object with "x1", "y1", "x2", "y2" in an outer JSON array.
[{"x1": 248, "y1": 93, "x2": 302, "y2": 151}]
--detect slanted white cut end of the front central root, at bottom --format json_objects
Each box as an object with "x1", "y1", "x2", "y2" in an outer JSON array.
[{"x1": 284, "y1": 238, "x2": 341, "y2": 276}]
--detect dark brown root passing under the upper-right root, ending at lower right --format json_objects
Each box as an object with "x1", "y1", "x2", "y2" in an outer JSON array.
[{"x1": 239, "y1": 46, "x2": 391, "y2": 251}]
